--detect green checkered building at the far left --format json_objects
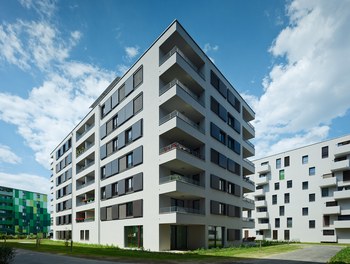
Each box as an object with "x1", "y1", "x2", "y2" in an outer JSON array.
[{"x1": 0, "y1": 186, "x2": 50, "y2": 235}]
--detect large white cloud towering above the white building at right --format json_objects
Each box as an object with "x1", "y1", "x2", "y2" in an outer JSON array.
[{"x1": 248, "y1": 0, "x2": 350, "y2": 156}]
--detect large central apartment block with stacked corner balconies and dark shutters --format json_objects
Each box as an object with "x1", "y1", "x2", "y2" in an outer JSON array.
[{"x1": 51, "y1": 21, "x2": 255, "y2": 251}]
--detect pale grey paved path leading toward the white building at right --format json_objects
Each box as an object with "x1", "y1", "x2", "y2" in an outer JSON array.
[{"x1": 239, "y1": 245, "x2": 343, "y2": 264}]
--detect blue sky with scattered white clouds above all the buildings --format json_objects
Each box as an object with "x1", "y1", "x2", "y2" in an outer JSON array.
[{"x1": 0, "y1": 0, "x2": 350, "y2": 193}]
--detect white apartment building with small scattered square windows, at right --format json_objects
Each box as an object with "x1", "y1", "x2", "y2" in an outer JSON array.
[{"x1": 246, "y1": 135, "x2": 350, "y2": 243}]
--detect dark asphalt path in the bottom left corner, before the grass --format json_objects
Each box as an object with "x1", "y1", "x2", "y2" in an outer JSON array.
[{"x1": 13, "y1": 249, "x2": 130, "y2": 264}]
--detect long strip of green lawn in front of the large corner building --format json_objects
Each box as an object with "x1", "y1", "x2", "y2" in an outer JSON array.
[{"x1": 0, "y1": 240, "x2": 302, "y2": 263}]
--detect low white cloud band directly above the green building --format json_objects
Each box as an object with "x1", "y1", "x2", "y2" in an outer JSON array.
[{"x1": 0, "y1": 172, "x2": 50, "y2": 195}]
